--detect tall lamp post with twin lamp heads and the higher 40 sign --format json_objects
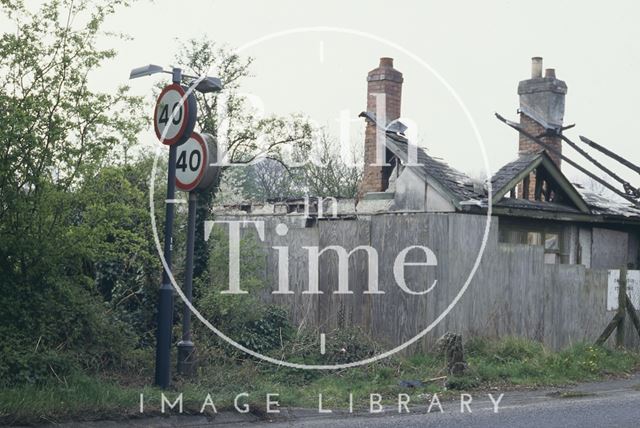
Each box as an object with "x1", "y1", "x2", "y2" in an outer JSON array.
[{"x1": 129, "y1": 64, "x2": 222, "y2": 388}]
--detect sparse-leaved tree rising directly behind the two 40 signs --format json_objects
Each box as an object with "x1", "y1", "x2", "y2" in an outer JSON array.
[{"x1": 171, "y1": 37, "x2": 313, "y2": 278}]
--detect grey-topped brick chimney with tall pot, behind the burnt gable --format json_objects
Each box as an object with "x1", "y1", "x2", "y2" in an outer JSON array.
[{"x1": 518, "y1": 57, "x2": 567, "y2": 198}]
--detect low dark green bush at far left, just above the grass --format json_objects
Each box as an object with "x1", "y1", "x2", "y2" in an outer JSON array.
[{"x1": 0, "y1": 272, "x2": 135, "y2": 385}]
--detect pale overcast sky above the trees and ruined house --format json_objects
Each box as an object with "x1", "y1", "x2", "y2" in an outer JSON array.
[{"x1": 5, "y1": 0, "x2": 640, "y2": 186}]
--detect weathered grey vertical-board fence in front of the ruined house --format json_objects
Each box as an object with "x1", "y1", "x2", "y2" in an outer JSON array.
[{"x1": 212, "y1": 213, "x2": 638, "y2": 353}]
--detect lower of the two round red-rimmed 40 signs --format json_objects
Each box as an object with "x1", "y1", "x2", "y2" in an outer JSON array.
[{"x1": 176, "y1": 132, "x2": 219, "y2": 192}]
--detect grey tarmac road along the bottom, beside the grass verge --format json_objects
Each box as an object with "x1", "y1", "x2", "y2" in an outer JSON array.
[{"x1": 37, "y1": 373, "x2": 640, "y2": 428}]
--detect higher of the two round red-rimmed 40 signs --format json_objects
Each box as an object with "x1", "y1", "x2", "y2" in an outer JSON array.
[{"x1": 153, "y1": 83, "x2": 197, "y2": 146}]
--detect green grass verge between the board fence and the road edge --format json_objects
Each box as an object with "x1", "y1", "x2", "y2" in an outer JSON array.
[{"x1": 0, "y1": 338, "x2": 640, "y2": 424}]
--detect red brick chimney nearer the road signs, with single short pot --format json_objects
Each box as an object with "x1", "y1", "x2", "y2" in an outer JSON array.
[{"x1": 358, "y1": 58, "x2": 403, "y2": 199}]
